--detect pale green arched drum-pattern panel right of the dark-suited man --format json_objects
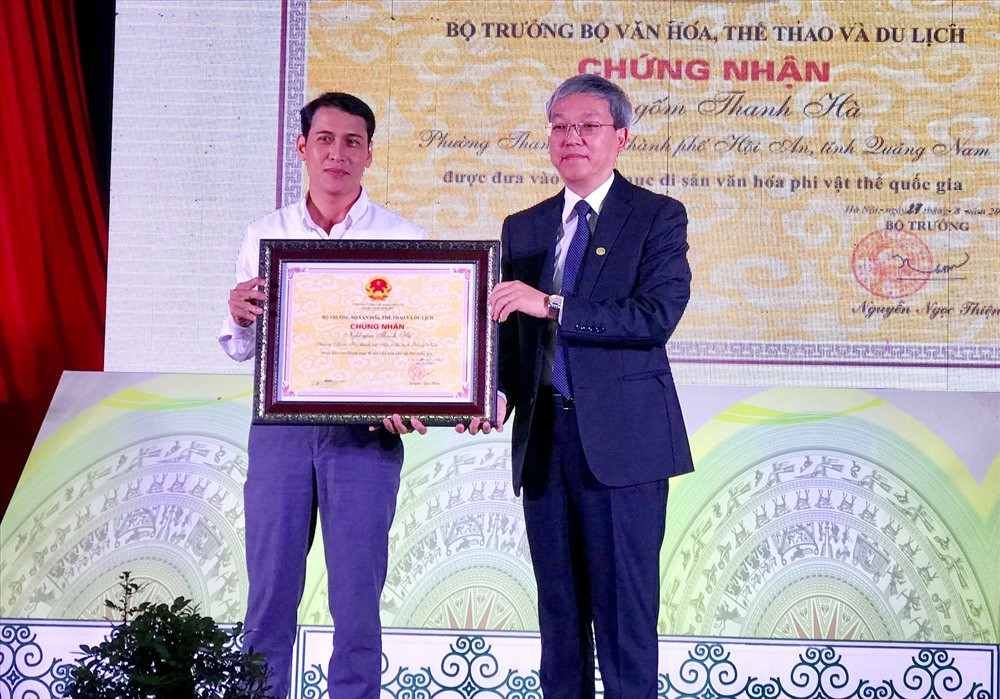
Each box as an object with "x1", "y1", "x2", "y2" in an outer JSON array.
[{"x1": 661, "y1": 389, "x2": 1000, "y2": 643}]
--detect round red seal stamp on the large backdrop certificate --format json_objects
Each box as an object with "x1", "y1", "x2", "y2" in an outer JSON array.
[{"x1": 851, "y1": 230, "x2": 934, "y2": 299}]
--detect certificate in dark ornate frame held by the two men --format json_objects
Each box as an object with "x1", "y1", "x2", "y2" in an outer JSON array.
[{"x1": 253, "y1": 240, "x2": 500, "y2": 425}]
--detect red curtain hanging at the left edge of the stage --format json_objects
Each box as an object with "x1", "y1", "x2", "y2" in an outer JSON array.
[{"x1": 0, "y1": 0, "x2": 108, "y2": 510}]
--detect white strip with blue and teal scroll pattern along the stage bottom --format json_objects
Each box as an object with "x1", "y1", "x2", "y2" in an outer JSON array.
[{"x1": 0, "y1": 620, "x2": 1000, "y2": 699}]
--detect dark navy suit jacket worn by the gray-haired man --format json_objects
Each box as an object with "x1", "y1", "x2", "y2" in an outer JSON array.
[{"x1": 500, "y1": 171, "x2": 693, "y2": 492}]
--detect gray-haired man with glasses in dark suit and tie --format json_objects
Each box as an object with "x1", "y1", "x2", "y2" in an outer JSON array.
[{"x1": 486, "y1": 75, "x2": 692, "y2": 699}]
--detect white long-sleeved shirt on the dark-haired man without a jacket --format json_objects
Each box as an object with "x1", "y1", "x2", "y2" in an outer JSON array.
[{"x1": 219, "y1": 188, "x2": 427, "y2": 361}]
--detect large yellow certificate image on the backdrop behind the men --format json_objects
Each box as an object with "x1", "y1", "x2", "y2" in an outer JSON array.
[{"x1": 279, "y1": 0, "x2": 1000, "y2": 378}]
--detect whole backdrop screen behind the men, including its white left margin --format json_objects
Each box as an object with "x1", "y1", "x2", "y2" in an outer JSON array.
[{"x1": 106, "y1": 0, "x2": 1000, "y2": 391}]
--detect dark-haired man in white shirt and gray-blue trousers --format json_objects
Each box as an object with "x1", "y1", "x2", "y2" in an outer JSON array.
[{"x1": 219, "y1": 92, "x2": 427, "y2": 699}]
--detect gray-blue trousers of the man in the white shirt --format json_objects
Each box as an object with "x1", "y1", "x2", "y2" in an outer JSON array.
[{"x1": 243, "y1": 425, "x2": 403, "y2": 699}]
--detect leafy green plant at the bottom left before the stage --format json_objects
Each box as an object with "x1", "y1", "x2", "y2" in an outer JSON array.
[{"x1": 65, "y1": 571, "x2": 269, "y2": 699}]
